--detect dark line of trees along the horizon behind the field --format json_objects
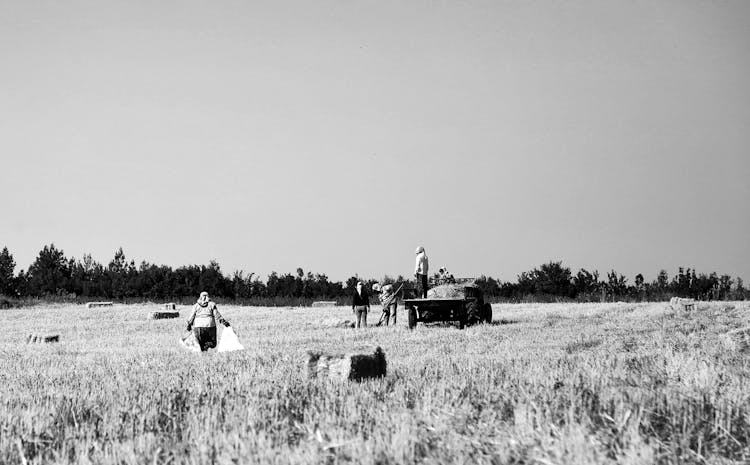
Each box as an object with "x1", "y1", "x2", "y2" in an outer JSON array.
[{"x1": 0, "y1": 244, "x2": 748, "y2": 305}]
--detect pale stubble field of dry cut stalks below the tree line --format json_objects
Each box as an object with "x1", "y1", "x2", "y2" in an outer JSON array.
[{"x1": 0, "y1": 302, "x2": 750, "y2": 465}]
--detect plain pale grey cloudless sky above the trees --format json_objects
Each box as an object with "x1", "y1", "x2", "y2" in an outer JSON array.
[{"x1": 0, "y1": 0, "x2": 750, "y2": 282}]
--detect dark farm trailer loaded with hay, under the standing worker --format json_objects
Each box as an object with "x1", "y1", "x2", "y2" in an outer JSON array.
[{"x1": 404, "y1": 280, "x2": 492, "y2": 329}]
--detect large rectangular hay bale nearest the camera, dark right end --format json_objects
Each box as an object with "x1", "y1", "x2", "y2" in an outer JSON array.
[{"x1": 307, "y1": 346, "x2": 387, "y2": 381}]
